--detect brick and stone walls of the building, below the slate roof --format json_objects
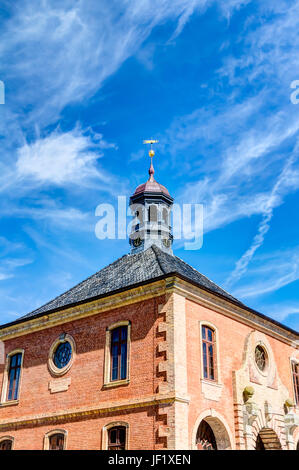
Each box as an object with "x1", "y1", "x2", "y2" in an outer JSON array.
[{"x1": 0, "y1": 278, "x2": 299, "y2": 450}]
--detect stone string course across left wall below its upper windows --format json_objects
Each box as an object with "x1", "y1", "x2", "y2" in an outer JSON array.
[{"x1": 0, "y1": 392, "x2": 189, "y2": 431}]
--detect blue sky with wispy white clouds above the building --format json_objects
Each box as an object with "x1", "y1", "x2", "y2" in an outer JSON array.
[{"x1": 0, "y1": 0, "x2": 299, "y2": 329}]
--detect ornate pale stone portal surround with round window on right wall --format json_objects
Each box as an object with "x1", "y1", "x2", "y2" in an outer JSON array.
[{"x1": 233, "y1": 331, "x2": 299, "y2": 449}]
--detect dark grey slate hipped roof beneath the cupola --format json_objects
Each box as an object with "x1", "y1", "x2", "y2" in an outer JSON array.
[{"x1": 19, "y1": 245, "x2": 243, "y2": 320}]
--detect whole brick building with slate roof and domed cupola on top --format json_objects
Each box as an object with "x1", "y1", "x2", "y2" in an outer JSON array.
[{"x1": 0, "y1": 154, "x2": 299, "y2": 450}]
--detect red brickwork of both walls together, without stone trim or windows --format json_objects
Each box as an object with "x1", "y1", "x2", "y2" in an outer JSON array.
[{"x1": 0, "y1": 297, "x2": 293, "y2": 449}]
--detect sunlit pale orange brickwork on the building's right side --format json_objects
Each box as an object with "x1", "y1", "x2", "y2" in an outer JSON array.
[{"x1": 186, "y1": 300, "x2": 295, "y2": 448}]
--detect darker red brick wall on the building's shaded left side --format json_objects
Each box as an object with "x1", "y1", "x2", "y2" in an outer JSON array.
[{"x1": 0, "y1": 298, "x2": 164, "y2": 449}]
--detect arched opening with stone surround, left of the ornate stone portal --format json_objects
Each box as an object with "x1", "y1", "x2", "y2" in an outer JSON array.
[{"x1": 192, "y1": 410, "x2": 232, "y2": 450}]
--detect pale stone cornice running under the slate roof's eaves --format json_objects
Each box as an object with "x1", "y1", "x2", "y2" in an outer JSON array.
[{"x1": 0, "y1": 274, "x2": 299, "y2": 349}]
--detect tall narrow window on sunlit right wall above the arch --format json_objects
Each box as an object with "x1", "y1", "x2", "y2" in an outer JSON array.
[{"x1": 201, "y1": 325, "x2": 217, "y2": 380}]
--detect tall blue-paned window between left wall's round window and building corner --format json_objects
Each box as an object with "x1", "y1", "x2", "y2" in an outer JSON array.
[{"x1": 110, "y1": 325, "x2": 128, "y2": 381}]
